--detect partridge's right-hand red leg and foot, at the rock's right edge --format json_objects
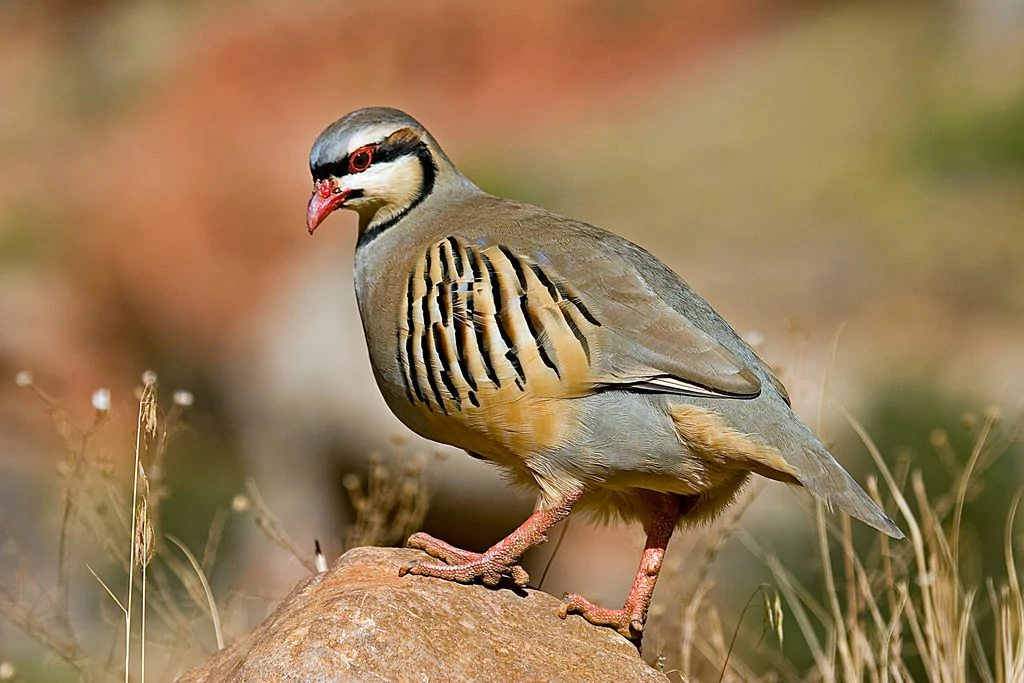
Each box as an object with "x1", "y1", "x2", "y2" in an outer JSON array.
[{"x1": 559, "y1": 495, "x2": 680, "y2": 641}]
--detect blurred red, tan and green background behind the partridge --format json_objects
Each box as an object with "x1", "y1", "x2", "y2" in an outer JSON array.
[{"x1": 0, "y1": 0, "x2": 1024, "y2": 680}]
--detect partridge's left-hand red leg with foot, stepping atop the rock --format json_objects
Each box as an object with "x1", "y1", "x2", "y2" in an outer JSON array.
[{"x1": 398, "y1": 488, "x2": 583, "y2": 586}]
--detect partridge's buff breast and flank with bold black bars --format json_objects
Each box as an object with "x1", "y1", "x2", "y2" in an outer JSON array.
[{"x1": 356, "y1": 238, "x2": 589, "y2": 462}]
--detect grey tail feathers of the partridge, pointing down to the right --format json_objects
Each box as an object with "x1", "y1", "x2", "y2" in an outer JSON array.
[{"x1": 781, "y1": 424, "x2": 906, "y2": 539}]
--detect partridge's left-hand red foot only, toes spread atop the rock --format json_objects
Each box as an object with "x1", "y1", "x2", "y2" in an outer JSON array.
[{"x1": 398, "y1": 533, "x2": 529, "y2": 587}]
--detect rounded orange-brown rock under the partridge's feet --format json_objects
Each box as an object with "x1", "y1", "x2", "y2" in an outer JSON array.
[{"x1": 178, "y1": 548, "x2": 668, "y2": 683}]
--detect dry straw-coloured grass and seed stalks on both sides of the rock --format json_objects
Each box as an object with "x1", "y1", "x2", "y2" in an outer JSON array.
[{"x1": 0, "y1": 376, "x2": 1024, "y2": 683}]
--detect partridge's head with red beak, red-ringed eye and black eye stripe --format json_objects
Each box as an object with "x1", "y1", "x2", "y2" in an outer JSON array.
[{"x1": 306, "y1": 108, "x2": 451, "y2": 234}]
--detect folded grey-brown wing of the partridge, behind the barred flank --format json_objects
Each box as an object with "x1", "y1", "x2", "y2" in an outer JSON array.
[{"x1": 468, "y1": 212, "x2": 777, "y2": 398}]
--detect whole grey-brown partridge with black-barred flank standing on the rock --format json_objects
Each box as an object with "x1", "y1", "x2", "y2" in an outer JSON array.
[{"x1": 306, "y1": 108, "x2": 903, "y2": 643}]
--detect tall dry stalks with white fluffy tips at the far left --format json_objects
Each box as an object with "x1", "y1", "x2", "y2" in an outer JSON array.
[{"x1": 0, "y1": 373, "x2": 224, "y2": 683}]
